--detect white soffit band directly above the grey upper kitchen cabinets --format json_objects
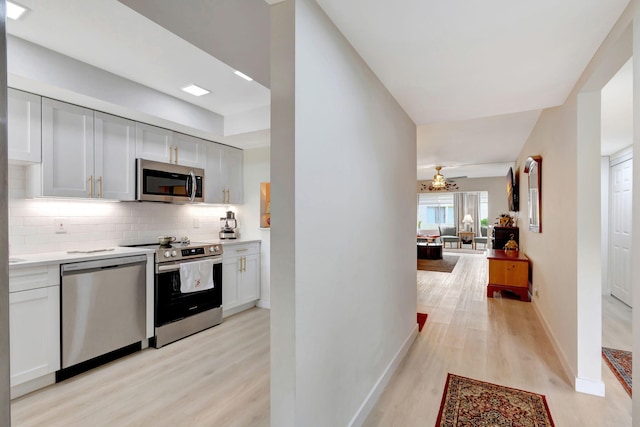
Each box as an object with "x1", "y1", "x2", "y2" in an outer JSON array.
[{"x1": 7, "y1": 36, "x2": 224, "y2": 141}]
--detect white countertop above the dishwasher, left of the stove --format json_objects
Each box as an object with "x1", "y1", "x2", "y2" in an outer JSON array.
[{"x1": 9, "y1": 246, "x2": 154, "y2": 270}]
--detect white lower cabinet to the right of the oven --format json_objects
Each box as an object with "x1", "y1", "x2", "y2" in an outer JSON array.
[{"x1": 222, "y1": 243, "x2": 260, "y2": 316}]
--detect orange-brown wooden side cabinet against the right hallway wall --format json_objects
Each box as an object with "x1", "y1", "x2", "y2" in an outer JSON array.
[{"x1": 487, "y1": 249, "x2": 531, "y2": 301}]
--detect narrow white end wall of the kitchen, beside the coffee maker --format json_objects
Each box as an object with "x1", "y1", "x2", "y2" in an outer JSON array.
[{"x1": 238, "y1": 147, "x2": 271, "y2": 308}]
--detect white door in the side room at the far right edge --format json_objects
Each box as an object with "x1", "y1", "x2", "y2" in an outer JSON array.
[{"x1": 609, "y1": 159, "x2": 633, "y2": 306}]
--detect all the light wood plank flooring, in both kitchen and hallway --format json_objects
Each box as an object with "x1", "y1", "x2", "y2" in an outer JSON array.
[{"x1": 12, "y1": 253, "x2": 631, "y2": 427}]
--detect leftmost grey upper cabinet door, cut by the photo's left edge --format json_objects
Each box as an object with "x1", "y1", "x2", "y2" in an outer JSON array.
[{"x1": 7, "y1": 88, "x2": 42, "y2": 163}]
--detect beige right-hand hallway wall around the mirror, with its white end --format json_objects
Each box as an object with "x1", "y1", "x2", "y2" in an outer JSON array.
[{"x1": 517, "y1": 0, "x2": 640, "y2": 400}]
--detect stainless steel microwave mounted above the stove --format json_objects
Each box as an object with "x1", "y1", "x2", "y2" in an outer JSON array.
[{"x1": 136, "y1": 159, "x2": 204, "y2": 203}]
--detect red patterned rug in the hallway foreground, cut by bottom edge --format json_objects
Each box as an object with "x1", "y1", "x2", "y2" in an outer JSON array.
[{"x1": 436, "y1": 374, "x2": 554, "y2": 427}]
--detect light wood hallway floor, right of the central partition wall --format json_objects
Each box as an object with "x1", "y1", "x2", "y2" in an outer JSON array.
[{"x1": 365, "y1": 254, "x2": 631, "y2": 427}]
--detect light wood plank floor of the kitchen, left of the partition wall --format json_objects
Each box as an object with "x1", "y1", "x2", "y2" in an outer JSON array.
[{"x1": 11, "y1": 308, "x2": 270, "y2": 427}]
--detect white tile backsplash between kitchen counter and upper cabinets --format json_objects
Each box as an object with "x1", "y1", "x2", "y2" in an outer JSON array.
[{"x1": 9, "y1": 165, "x2": 242, "y2": 256}]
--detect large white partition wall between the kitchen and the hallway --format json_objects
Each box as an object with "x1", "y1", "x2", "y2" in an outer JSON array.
[{"x1": 271, "y1": 0, "x2": 416, "y2": 426}]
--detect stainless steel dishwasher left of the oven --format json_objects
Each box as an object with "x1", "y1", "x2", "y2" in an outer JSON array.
[{"x1": 60, "y1": 255, "x2": 147, "y2": 369}]
